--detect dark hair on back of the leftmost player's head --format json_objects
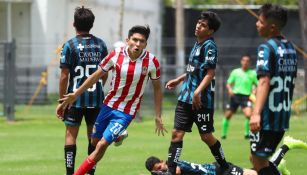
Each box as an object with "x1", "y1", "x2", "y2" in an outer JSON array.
[{"x1": 74, "y1": 6, "x2": 95, "y2": 32}]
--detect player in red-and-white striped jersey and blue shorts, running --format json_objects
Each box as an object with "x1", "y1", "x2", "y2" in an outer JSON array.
[{"x1": 60, "y1": 26, "x2": 166, "y2": 175}]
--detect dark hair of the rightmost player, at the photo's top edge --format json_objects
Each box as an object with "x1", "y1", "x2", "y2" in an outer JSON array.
[{"x1": 258, "y1": 3, "x2": 288, "y2": 30}]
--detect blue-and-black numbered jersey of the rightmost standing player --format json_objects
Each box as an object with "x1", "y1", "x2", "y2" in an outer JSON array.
[{"x1": 257, "y1": 37, "x2": 297, "y2": 131}]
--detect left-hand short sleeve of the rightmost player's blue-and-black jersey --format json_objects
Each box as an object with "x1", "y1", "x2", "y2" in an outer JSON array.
[{"x1": 256, "y1": 44, "x2": 271, "y2": 77}]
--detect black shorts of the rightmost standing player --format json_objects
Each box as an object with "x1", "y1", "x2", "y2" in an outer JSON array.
[{"x1": 249, "y1": 130, "x2": 285, "y2": 157}]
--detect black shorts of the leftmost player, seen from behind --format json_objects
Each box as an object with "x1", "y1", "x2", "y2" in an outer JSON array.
[{"x1": 64, "y1": 107, "x2": 100, "y2": 126}]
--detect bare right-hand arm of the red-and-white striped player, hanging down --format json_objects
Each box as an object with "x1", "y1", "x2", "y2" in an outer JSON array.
[{"x1": 152, "y1": 79, "x2": 167, "y2": 136}]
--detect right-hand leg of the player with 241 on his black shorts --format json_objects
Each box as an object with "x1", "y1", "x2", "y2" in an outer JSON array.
[{"x1": 193, "y1": 108, "x2": 229, "y2": 171}]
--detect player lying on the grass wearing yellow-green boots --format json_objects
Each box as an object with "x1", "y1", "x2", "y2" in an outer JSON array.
[{"x1": 145, "y1": 136, "x2": 307, "y2": 175}]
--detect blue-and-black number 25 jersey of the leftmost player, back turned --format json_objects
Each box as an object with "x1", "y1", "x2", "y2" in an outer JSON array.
[{"x1": 60, "y1": 34, "x2": 108, "y2": 108}]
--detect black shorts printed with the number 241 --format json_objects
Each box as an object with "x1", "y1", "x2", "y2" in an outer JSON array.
[{"x1": 174, "y1": 101, "x2": 214, "y2": 134}]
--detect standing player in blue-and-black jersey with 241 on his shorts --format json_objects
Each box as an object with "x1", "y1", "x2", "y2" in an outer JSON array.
[{"x1": 166, "y1": 11, "x2": 229, "y2": 175}]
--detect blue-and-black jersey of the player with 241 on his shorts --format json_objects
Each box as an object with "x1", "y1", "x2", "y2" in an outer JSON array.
[{"x1": 178, "y1": 38, "x2": 218, "y2": 109}]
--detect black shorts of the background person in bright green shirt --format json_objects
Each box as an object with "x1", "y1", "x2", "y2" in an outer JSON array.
[{"x1": 226, "y1": 94, "x2": 252, "y2": 112}]
